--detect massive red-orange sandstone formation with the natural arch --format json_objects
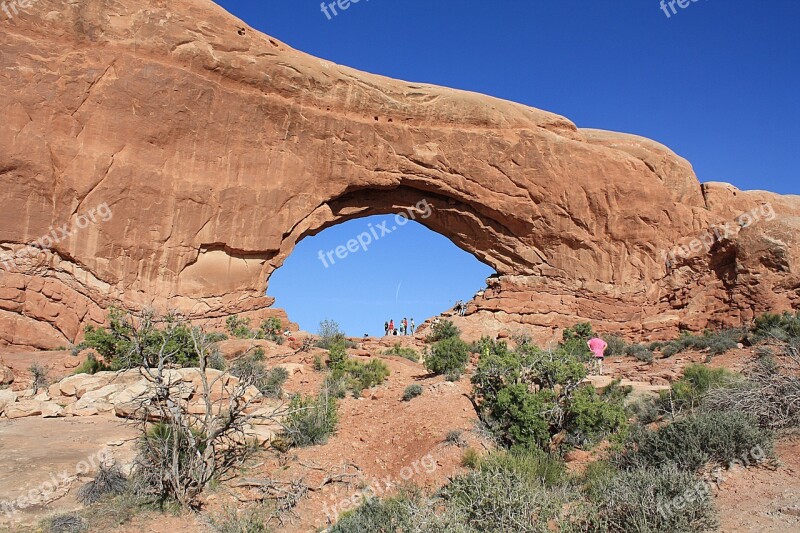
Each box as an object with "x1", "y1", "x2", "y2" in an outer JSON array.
[{"x1": 0, "y1": 0, "x2": 800, "y2": 348}]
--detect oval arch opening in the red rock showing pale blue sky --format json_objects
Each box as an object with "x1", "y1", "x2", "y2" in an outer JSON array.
[{"x1": 267, "y1": 215, "x2": 494, "y2": 337}]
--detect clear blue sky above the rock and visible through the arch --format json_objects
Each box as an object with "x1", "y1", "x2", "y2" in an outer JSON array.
[{"x1": 212, "y1": 0, "x2": 800, "y2": 335}]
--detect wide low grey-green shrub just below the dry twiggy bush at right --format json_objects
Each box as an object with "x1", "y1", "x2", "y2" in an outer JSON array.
[{"x1": 615, "y1": 412, "x2": 773, "y2": 471}]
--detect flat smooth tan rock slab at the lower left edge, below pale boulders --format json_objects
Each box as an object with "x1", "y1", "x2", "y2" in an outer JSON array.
[{"x1": 0, "y1": 417, "x2": 135, "y2": 530}]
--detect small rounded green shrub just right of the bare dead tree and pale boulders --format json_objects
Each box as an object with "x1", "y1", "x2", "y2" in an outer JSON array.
[{"x1": 283, "y1": 389, "x2": 339, "y2": 447}]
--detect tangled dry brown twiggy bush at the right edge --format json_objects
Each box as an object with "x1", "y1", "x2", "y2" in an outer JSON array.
[{"x1": 702, "y1": 355, "x2": 800, "y2": 430}]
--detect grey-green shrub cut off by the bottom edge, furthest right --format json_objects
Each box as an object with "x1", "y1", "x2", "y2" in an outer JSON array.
[{"x1": 589, "y1": 465, "x2": 718, "y2": 533}]
